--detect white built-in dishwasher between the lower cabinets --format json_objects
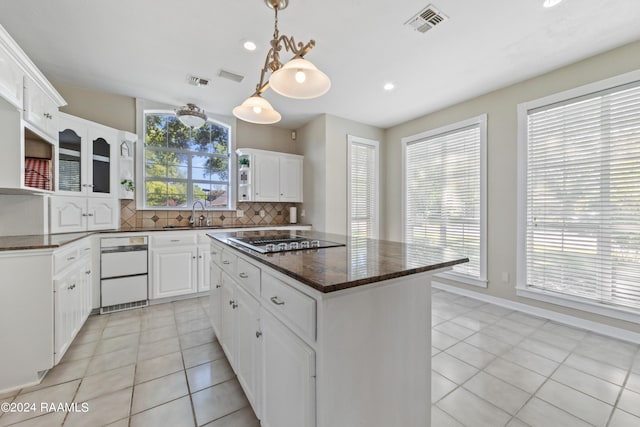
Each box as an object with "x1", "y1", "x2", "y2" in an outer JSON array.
[{"x1": 100, "y1": 236, "x2": 149, "y2": 313}]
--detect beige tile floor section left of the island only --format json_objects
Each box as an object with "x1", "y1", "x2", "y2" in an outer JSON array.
[{"x1": 0, "y1": 298, "x2": 259, "y2": 427}]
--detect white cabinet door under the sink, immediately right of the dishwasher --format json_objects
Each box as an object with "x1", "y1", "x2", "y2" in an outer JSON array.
[{"x1": 151, "y1": 246, "x2": 198, "y2": 298}]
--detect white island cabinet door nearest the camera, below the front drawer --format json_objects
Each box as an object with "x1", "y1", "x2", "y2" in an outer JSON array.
[{"x1": 260, "y1": 309, "x2": 316, "y2": 427}]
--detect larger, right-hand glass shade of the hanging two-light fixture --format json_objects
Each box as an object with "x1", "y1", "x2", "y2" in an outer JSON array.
[{"x1": 269, "y1": 58, "x2": 331, "y2": 99}]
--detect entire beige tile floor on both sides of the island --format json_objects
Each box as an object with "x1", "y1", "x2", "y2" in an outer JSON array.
[{"x1": 0, "y1": 290, "x2": 640, "y2": 427}]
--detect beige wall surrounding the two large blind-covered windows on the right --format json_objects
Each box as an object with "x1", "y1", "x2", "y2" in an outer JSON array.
[{"x1": 382, "y1": 42, "x2": 640, "y2": 331}]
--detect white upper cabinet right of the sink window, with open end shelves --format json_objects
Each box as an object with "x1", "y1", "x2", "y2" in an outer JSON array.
[{"x1": 236, "y1": 148, "x2": 304, "y2": 203}]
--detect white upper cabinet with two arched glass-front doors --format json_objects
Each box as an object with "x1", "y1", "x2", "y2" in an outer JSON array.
[{"x1": 57, "y1": 113, "x2": 119, "y2": 198}]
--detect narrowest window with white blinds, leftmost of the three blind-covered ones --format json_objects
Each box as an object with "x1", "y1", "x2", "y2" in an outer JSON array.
[{"x1": 347, "y1": 135, "x2": 379, "y2": 239}]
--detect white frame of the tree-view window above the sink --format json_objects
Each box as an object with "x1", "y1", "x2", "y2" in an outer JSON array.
[{"x1": 135, "y1": 105, "x2": 237, "y2": 212}]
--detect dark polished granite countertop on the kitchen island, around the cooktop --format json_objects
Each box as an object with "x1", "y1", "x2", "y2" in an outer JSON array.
[{"x1": 209, "y1": 231, "x2": 469, "y2": 293}]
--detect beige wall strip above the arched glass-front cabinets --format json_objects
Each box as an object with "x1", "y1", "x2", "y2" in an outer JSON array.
[{"x1": 54, "y1": 84, "x2": 136, "y2": 133}]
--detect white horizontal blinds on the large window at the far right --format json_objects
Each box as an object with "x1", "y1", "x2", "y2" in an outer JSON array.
[{"x1": 526, "y1": 82, "x2": 640, "y2": 308}]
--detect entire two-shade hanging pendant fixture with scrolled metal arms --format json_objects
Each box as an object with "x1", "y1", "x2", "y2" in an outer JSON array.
[{"x1": 233, "y1": 0, "x2": 331, "y2": 124}]
